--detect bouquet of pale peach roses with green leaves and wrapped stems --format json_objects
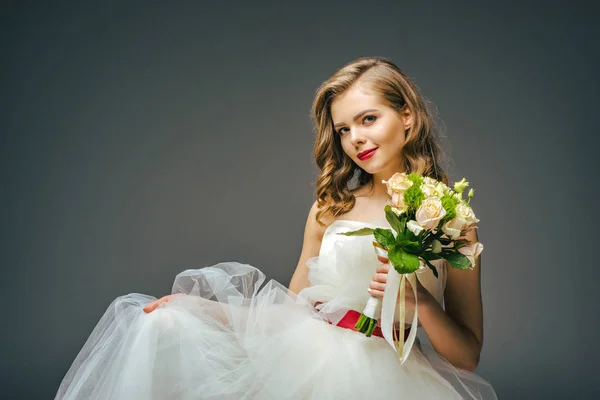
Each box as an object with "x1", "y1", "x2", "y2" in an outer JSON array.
[{"x1": 340, "y1": 172, "x2": 483, "y2": 362}]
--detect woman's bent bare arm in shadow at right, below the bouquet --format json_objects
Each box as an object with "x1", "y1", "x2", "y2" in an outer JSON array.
[{"x1": 418, "y1": 229, "x2": 483, "y2": 371}]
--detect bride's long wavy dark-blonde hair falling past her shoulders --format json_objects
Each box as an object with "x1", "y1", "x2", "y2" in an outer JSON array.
[{"x1": 311, "y1": 57, "x2": 448, "y2": 226}]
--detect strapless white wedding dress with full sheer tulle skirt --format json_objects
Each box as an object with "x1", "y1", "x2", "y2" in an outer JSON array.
[{"x1": 56, "y1": 220, "x2": 497, "y2": 400}]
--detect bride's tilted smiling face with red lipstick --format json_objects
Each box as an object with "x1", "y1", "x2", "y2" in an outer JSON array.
[{"x1": 331, "y1": 84, "x2": 412, "y2": 179}]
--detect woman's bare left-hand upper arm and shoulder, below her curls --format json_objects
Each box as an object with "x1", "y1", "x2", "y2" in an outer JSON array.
[{"x1": 289, "y1": 201, "x2": 332, "y2": 294}]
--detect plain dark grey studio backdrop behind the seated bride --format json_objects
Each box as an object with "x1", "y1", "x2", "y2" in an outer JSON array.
[{"x1": 0, "y1": 1, "x2": 600, "y2": 399}]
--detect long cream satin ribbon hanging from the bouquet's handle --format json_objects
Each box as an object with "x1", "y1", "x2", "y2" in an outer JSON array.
[{"x1": 381, "y1": 267, "x2": 419, "y2": 364}]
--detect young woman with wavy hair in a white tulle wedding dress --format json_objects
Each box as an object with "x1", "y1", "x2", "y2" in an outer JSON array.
[{"x1": 56, "y1": 58, "x2": 496, "y2": 400}]
